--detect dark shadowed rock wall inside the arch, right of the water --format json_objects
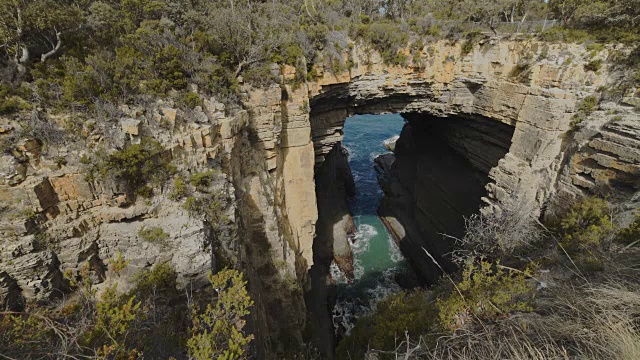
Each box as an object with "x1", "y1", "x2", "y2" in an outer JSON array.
[{"x1": 376, "y1": 115, "x2": 513, "y2": 284}]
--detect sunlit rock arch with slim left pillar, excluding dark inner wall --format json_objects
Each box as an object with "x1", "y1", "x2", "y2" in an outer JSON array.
[{"x1": 264, "y1": 40, "x2": 638, "y2": 272}]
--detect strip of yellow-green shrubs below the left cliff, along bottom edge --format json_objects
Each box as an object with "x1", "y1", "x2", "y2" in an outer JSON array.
[{"x1": 0, "y1": 262, "x2": 253, "y2": 360}]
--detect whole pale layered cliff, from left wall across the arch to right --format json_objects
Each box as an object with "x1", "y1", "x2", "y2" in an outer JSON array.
[{"x1": 0, "y1": 39, "x2": 640, "y2": 358}]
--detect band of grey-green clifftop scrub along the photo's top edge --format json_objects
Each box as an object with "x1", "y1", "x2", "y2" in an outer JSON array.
[{"x1": 0, "y1": 0, "x2": 639, "y2": 118}]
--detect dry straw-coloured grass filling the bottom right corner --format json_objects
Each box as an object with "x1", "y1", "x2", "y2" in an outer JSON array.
[{"x1": 367, "y1": 279, "x2": 640, "y2": 360}]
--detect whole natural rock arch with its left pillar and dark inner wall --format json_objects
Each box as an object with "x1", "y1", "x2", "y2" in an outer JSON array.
[{"x1": 241, "y1": 39, "x2": 640, "y2": 354}]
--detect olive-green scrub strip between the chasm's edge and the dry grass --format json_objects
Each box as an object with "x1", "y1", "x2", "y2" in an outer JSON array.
[{"x1": 338, "y1": 259, "x2": 534, "y2": 359}]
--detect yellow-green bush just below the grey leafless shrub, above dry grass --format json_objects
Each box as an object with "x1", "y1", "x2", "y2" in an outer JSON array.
[{"x1": 436, "y1": 260, "x2": 533, "y2": 332}]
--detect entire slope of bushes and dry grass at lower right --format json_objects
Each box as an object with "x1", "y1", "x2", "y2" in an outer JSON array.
[{"x1": 338, "y1": 198, "x2": 640, "y2": 360}]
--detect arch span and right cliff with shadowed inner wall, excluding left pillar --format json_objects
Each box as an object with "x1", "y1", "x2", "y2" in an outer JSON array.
[{"x1": 302, "y1": 39, "x2": 640, "y2": 288}]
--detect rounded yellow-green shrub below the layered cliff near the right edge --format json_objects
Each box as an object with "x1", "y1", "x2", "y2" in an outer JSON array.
[{"x1": 559, "y1": 197, "x2": 615, "y2": 254}]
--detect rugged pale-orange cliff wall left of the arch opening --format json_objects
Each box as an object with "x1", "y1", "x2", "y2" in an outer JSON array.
[{"x1": 0, "y1": 93, "x2": 310, "y2": 358}]
